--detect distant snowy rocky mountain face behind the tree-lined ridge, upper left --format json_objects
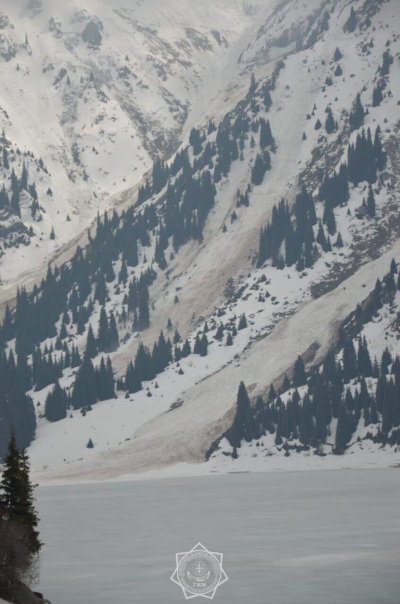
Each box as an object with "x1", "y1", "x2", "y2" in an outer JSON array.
[{"x1": 0, "y1": 0, "x2": 273, "y2": 282}]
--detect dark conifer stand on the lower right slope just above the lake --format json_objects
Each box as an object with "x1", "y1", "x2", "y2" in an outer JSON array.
[{"x1": 227, "y1": 261, "x2": 400, "y2": 457}]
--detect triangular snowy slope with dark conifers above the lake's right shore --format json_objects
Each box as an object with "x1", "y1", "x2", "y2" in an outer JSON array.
[{"x1": 209, "y1": 260, "x2": 400, "y2": 470}]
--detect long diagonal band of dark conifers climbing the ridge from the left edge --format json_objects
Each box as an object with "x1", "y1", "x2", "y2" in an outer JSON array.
[{"x1": 0, "y1": 69, "x2": 275, "y2": 455}]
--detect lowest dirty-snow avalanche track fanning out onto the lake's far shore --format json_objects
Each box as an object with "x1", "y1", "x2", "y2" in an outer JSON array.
[{"x1": 30, "y1": 241, "x2": 400, "y2": 483}]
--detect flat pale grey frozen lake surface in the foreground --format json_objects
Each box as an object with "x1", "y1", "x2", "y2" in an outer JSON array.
[{"x1": 37, "y1": 469, "x2": 400, "y2": 604}]
